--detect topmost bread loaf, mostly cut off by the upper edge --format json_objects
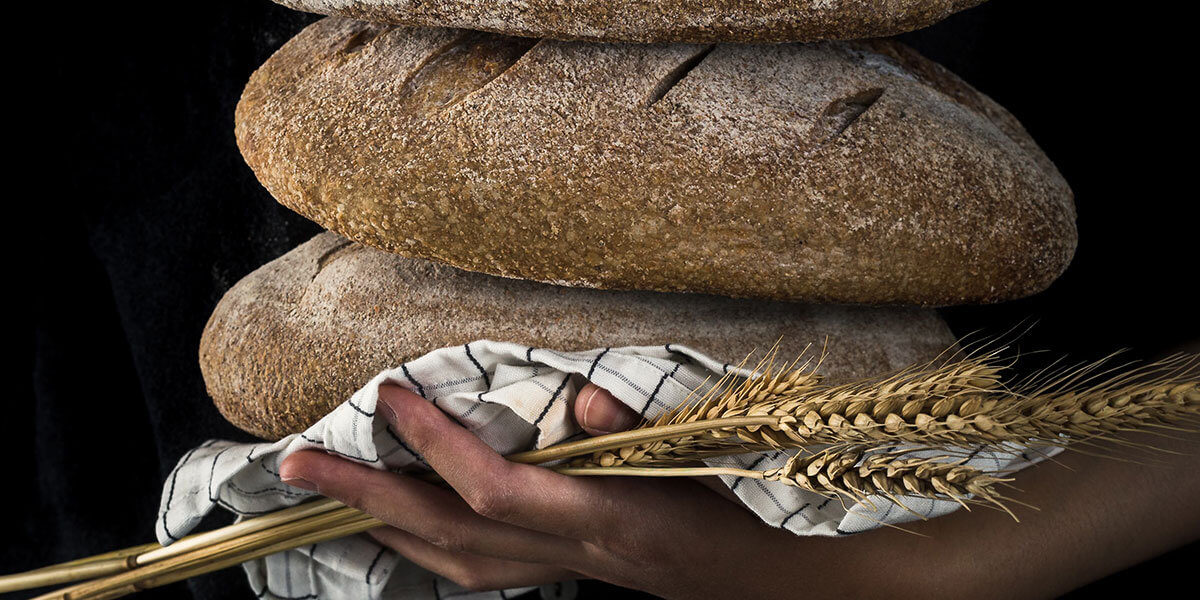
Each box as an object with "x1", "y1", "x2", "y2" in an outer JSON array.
[{"x1": 275, "y1": 0, "x2": 984, "y2": 42}]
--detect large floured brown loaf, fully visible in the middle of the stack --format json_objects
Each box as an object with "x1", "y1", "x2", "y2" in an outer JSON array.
[{"x1": 236, "y1": 18, "x2": 1075, "y2": 305}]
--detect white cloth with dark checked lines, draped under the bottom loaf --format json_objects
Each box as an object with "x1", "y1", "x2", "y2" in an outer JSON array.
[{"x1": 156, "y1": 340, "x2": 1046, "y2": 600}]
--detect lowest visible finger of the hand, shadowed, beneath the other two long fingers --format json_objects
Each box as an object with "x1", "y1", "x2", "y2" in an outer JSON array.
[{"x1": 367, "y1": 527, "x2": 580, "y2": 592}]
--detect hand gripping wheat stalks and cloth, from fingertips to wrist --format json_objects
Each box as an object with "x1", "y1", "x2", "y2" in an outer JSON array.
[{"x1": 281, "y1": 384, "x2": 794, "y2": 598}]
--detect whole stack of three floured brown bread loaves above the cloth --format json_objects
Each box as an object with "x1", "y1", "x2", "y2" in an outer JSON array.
[{"x1": 200, "y1": 0, "x2": 1075, "y2": 438}]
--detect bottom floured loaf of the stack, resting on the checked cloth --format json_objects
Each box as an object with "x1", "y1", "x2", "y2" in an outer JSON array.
[{"x1": 200, "y1": 233, "x2": 954, "y2": 439}]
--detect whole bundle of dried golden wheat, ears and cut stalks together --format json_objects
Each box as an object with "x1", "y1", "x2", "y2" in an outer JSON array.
[{"x1": 11, "y1": 352, "x2": 1200, "y2": 599}]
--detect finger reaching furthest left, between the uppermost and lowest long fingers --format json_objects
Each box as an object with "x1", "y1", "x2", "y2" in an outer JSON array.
[{"x1": 280, "y1": 450, "x2": 582, "y2": 564}]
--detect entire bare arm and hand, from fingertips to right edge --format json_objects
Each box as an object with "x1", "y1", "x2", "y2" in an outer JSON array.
[{"x1": 281, "y1": 386, "x2": 1200, "y2": 599}]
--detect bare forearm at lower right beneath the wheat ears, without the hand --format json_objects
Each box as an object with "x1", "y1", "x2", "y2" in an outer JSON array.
[{"x1": 775, "y1": 434, "x2": 1200, "y2": 598}]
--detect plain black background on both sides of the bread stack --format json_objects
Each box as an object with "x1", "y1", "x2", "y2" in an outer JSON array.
[{"x1": 7, "y1": 0, "x2": 1200, "y2": 598}]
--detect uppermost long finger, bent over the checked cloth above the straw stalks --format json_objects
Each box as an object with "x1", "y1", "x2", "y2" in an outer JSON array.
[{"x1": 379, "y1": 385, "x2": 617, "y2": 540}]
